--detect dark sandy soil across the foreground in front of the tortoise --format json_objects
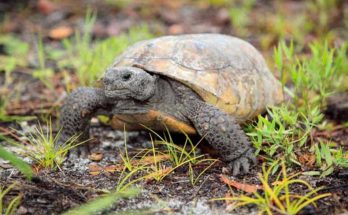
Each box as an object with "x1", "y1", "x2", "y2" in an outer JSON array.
[{"x1": 0, "y1": 127, "x2": 348, "y2": 214}]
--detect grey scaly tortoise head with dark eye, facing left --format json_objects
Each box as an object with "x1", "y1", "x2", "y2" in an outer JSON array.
[{"x1": 104, "y1": 67, "x2": 157, "y2": 101}]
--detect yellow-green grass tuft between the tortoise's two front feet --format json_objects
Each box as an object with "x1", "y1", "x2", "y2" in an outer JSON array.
[{"x1": 116, "y1": 128, "x2": 217, "y2": 188}]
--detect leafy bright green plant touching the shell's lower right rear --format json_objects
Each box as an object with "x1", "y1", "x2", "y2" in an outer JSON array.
[{"x1": 247, "y1": 105, "x2": 323, "y2": 169}]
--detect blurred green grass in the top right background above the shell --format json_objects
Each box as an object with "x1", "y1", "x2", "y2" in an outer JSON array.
[{"x1": 230, "y1": 0, "x2": 348, "y2": 48}]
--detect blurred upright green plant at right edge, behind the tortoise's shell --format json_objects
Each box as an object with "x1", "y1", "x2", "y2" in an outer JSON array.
[{"x1": 274, "y1": 41, "x2": 348, "y2": 112}]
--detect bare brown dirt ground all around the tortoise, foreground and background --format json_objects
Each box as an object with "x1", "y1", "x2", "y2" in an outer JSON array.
[{"x1": 0, "y1": 0, "x2": 348, "y2": 215}]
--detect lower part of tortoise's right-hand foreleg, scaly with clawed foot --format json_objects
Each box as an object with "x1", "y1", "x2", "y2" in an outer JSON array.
[{"x1": 191, "y1": 104, "x2": 256, "y2": 175}]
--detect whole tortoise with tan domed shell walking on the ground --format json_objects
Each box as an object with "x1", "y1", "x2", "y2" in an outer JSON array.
[{"x1": 60, "y1": 34, "x2": 283, "y2": 175}]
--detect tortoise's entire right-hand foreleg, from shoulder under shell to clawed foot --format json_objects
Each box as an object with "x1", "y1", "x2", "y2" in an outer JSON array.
[{"x1": 172, "y1": 81, "x2": 256, "y2": 175}]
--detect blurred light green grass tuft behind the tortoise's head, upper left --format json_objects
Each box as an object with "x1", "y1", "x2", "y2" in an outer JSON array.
[{"x1": 58, "y1": 10, "x2": 153, "y2": 86}]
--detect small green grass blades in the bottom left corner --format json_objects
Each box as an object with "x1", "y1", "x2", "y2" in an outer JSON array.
[{"x1": 0, "y1": 183, "x2": 22, "y2": 215}]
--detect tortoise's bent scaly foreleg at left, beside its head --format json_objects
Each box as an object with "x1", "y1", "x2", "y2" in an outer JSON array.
[{"x1": 58, "y1": 87, "x2": 107, "y2": 154}]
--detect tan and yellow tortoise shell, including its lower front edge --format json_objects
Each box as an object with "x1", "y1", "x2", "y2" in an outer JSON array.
[{"x1": 106, "y1": 34, "x2": 283, "y2": 133}]
